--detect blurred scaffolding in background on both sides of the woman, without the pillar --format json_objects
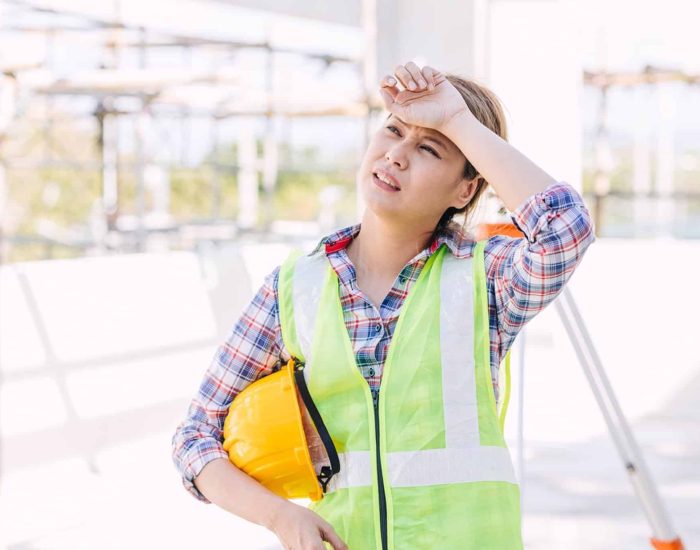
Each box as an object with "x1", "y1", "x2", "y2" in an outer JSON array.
[{"x1": 0, "y1": 0, "x2": 700, "y2": 262}]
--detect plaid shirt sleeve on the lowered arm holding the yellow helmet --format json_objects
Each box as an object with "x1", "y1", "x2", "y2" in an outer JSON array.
[{"x1": 172, "y1": 268, "x2": 279, "y2": 502}]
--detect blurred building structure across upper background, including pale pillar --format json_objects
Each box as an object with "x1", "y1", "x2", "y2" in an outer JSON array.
[{"x1": 0, "y1": 0, "x2": 700, "y2": 261}]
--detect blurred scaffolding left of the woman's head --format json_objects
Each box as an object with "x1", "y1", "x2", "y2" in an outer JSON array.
[{"x1": 0, "y1": 0, "x2": 379, "y2": 264}]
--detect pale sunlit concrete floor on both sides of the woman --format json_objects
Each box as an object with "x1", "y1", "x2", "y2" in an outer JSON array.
[{"x1": 0, "y1": 242, "x2": 700, "y2": 550}]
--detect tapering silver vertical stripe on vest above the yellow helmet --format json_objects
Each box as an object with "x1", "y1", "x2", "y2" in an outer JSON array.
[{"x1": 292, "y1": 251, "x2": 329, "y2": 382}]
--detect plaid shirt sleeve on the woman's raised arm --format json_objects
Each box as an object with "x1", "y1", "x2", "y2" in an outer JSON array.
[{"x1": 485, "y1": 182, "x2": 595, "y2": 344}]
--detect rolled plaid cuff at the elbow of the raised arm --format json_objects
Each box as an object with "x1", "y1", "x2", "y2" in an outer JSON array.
[{"x1": 511, "y1": 182, "x2": 586, "y2": 243}]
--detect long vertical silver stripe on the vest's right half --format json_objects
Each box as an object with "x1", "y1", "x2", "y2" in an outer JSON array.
[{"x1": 440, "y1": 253, "x2": 479, "y2": 449}]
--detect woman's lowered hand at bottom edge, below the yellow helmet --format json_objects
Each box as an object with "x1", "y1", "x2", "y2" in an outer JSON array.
[{"x1": 267, "y1": 501, "x2": 348, "y2": 550}]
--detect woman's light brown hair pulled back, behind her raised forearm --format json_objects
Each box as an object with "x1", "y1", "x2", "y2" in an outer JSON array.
[{"x1": 435, "y1": 74, "x2": 508, "y2": 233}]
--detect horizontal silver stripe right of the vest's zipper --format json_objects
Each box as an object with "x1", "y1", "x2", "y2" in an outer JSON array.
[{"x1": 387, "y1": 446, "x2": 517, "y2": 487}]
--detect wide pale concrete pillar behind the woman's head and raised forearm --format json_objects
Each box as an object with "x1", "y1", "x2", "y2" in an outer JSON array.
[{"x1": 364, "y1": 0, "x2": 583, "y2": 197}]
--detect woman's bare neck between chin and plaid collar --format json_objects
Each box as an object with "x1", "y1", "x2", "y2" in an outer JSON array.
[{"x1": 348, "y1": 210, "x2": 433, "y2": 276}]
